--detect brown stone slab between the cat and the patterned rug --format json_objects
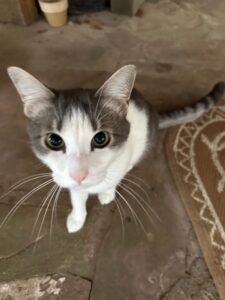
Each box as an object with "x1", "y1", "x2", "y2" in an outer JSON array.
[{"x1": 91, "y1": 134, "x2": 219, "y2": 300}]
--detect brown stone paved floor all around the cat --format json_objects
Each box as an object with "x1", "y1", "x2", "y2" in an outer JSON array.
[{"x1": 0, "y1": 0, "x2": 225, "y2": 300}]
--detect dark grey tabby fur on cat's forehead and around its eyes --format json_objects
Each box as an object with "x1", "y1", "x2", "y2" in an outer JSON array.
[{"x1": 28, "y1": 89, "x2": 130, "y2": 155}]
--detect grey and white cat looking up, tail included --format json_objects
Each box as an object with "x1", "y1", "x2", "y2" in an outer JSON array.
[{"x1": 8, "y1": 65, "x2": 225, "y2": 232}]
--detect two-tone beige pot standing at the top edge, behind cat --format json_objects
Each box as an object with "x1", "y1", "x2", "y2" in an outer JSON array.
[{"x1": 39, "y1": 0, "x2": 68, "y2": 27}]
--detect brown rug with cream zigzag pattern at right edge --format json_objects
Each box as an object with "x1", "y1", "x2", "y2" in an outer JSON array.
[{"x1": 166, "y1": 106, "x2": 225, "y2": 300}]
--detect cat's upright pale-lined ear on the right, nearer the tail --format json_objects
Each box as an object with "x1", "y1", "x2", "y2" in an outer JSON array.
[{"x1": 96, "y1": 65, "x2": 136, "y2": 113}]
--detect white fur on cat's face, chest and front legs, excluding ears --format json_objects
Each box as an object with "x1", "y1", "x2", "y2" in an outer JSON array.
[{"x1": 38, "y1": 102, "x2": 148, "y2": 232}]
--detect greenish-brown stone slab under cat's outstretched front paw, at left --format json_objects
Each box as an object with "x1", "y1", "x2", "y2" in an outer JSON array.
[{"x1": 0, "y1": 199, "x2": 113, "y2": 281}]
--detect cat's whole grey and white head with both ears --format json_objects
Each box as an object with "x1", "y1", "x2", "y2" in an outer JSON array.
[{"x1": 8, "y1": 65, "x2": 136, "y2": 188}]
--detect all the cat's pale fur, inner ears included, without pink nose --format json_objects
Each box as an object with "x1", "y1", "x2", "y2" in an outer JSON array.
[{"x1": 8, "y1": 65, "x2": 148, "y2": 232}]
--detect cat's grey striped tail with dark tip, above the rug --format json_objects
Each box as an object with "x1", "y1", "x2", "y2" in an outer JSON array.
[{"x1": 159, "y1": 82, "x2": 225, "y2": 128}]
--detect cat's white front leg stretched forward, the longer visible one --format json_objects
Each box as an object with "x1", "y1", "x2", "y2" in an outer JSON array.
[{"x1": 67, "y1": 189, "x2": 88, "y2": 233}]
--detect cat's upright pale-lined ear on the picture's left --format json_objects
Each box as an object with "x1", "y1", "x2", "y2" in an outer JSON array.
[{"x1": 7, "y1": 67, "x2": 55, "y2": 119}]
